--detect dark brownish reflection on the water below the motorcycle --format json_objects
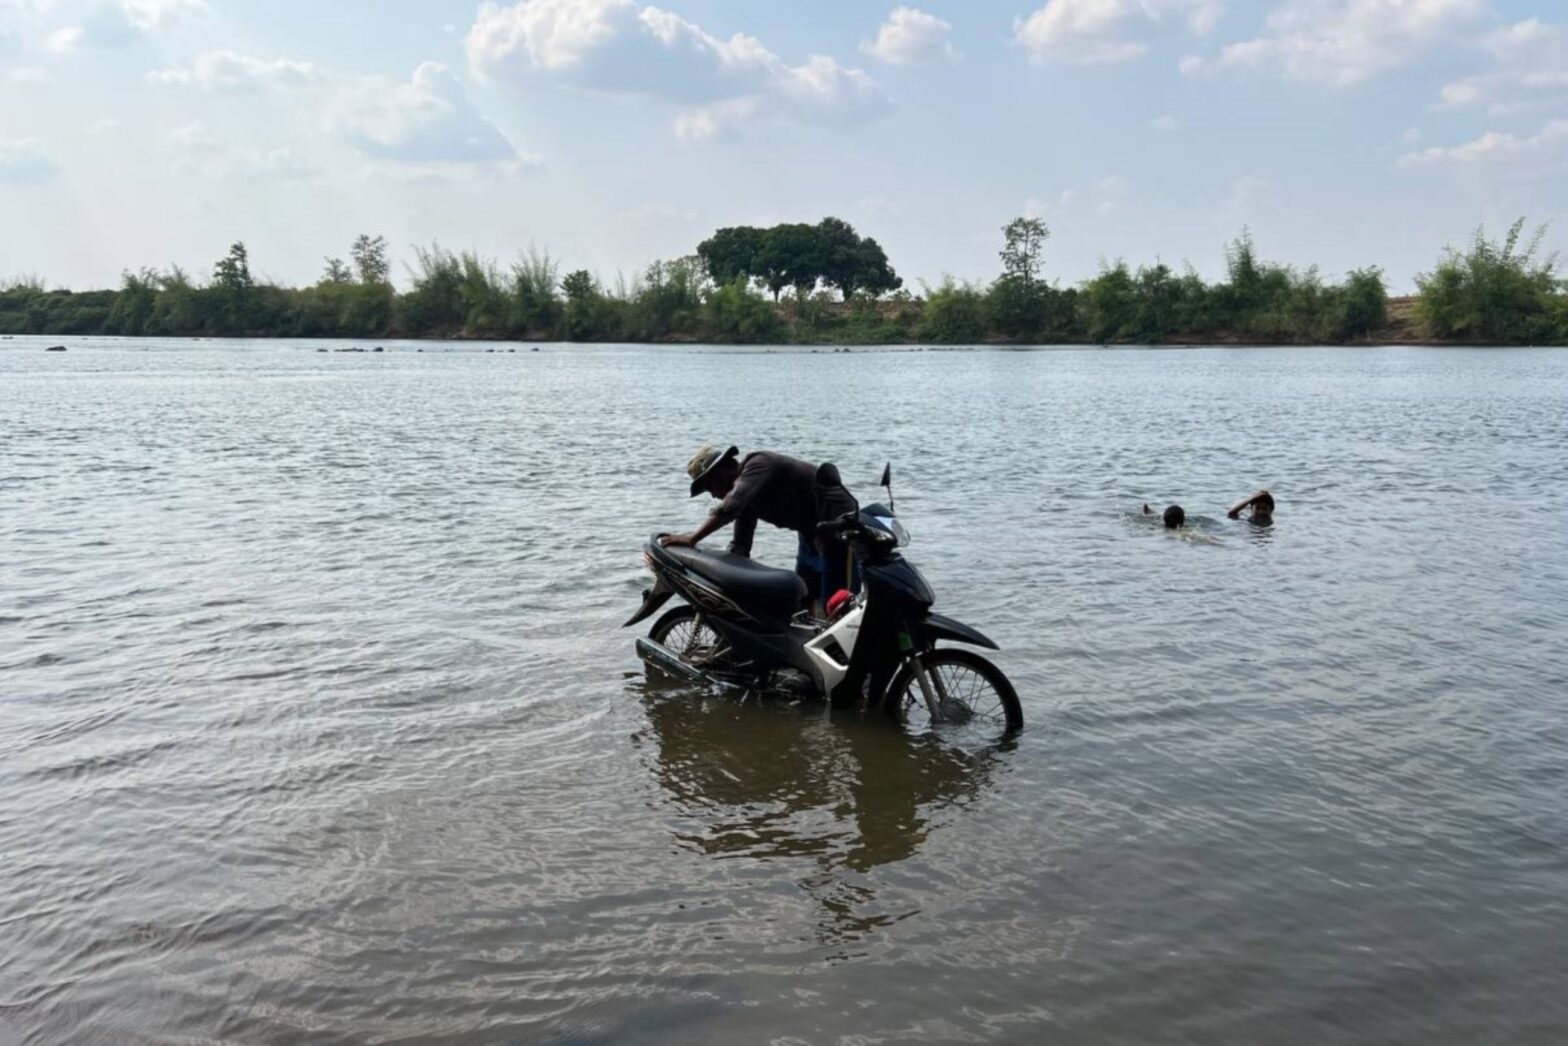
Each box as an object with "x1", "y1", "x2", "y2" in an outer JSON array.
[{"x1": 627, "y1": 673, "x2": 1013, "y2": 942}]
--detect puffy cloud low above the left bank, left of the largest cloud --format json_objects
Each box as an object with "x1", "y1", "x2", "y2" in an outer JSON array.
[{"x1": 326, "y1": 61, "x2": 517, "y2": 163}]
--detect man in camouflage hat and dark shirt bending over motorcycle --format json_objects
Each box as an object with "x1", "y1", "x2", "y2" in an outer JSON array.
[{"x1": 662, "y1": 444, "x2": 859, "y2": 613}]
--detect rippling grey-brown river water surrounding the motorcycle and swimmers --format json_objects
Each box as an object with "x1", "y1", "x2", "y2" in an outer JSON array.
[{"x1": 0, "y1": 339, "x2": 1568, "y2": 1044}]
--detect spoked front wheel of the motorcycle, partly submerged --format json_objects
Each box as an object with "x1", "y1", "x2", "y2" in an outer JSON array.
[{"x1": 887, "y1": 648, "x2": 1024, "y2": 737}]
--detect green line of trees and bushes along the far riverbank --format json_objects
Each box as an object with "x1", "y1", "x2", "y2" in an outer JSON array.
[{"x1": 0, "y1": 218, "x2": 1568, "y2": 345}]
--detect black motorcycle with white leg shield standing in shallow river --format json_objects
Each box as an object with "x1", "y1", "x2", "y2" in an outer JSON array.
[{"x1": 622, "y1": 464, "x2": 1024, "y2": 735}]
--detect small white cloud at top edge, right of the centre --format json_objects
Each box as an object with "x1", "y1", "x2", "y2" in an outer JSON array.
[{"x1": 1013, "y1": 0, "x2": 1225, "y2": 64}]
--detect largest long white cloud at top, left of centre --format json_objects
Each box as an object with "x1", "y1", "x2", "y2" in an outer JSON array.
[{"x1": 466, "y1": 0, "x2": 887, "y2": 141}]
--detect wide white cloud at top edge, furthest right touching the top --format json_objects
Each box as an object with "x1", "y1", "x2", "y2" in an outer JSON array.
[{"x1": 1181, "y1": 0, "x2": 1491, "y2": 88}]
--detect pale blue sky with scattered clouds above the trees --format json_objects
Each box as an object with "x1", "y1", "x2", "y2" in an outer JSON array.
[{"x1": 0, "y1": 0, "x2": 1568, "y2": 293}]
